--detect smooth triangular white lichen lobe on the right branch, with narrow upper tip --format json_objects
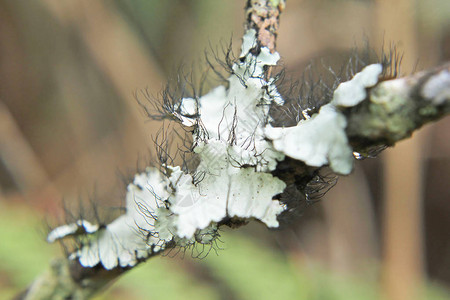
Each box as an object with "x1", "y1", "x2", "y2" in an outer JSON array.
[{"x1": 265, "y1": 64, "x2": 383, "y2": 175}]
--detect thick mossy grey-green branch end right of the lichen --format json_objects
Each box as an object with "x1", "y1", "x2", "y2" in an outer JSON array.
[{"x1": 344, "y1": 63, "x2": 450, "y2": 152}]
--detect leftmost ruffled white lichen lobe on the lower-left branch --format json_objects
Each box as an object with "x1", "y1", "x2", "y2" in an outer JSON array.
[{"x1": 47, "y1": 168, "x2": 168, "y2": 270}]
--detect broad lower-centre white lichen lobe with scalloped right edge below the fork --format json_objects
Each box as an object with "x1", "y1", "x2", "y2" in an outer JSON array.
[{"x1": 169, "y1": 140, "x2": 286, "y2": 238}]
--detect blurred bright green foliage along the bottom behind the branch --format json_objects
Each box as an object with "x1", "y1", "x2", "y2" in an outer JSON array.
[{"x1": 0, "y1": 205, "x2": 450, "y2": 300}]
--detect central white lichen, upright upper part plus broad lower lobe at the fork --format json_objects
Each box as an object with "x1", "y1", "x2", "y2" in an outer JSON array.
[{"x1": 165, "y1": 30, "x2": 285, "y2": 238}]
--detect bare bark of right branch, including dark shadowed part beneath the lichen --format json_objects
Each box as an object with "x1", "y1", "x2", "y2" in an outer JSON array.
[{"x1": 272, "y1": 63, "x2": 450, "y2": 219}]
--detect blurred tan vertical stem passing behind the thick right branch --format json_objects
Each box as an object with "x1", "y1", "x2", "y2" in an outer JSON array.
[{"x1": 375, "y1": 0, "x2": 424, "y2": 300}]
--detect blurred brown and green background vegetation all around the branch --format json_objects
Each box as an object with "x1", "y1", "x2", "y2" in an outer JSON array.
[{"x1": 0, "y1": 0, "x2": 450, "y2": 300}]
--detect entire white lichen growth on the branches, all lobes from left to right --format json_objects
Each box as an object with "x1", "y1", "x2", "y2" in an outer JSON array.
[{"x1": 48, "y1": 30, "x2": 381, "y2": 269}]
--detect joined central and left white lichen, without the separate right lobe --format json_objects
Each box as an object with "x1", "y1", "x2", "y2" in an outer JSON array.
[{"x1": 49, "y1": 30, "x2": 286, "y2": 269}]
